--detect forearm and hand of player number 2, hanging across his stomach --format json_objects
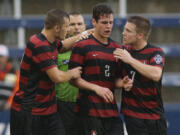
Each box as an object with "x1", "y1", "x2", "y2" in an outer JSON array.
[{"x1": 70, "y1": 78, "x2": 114, "y2": 102}]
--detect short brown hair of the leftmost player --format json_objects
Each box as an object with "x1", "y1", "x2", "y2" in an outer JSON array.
[{"x1": 44, "y1": 9, "x2": 69, "y2": 29}]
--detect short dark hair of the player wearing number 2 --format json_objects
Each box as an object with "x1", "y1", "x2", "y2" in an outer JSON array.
[{"x1": 92, "y1": 3, "x2": 113, "y2": 22}]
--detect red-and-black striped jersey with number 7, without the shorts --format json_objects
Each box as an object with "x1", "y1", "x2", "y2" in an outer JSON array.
[{"x1": 121, "y1": 44, "x2": 165, "y2": 120}]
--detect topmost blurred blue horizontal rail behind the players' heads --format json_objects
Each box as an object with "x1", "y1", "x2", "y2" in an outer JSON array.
[{"x1": 0, "y1": 15, "x2": 180, "y2": 29}]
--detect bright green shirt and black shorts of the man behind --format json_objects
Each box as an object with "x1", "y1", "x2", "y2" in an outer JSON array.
[{"x1": 56, "y1": 51, "x2": 78, "y2": 135}]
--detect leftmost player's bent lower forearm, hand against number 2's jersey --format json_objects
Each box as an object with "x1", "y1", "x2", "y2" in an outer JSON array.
[{"x1": 46, "y1": 66, "x2": 81, "y2": 83}]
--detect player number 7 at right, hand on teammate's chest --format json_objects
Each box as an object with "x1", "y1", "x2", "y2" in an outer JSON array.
[{"x1": 114, "y1": 16, "x2": 167, "y2": 135}]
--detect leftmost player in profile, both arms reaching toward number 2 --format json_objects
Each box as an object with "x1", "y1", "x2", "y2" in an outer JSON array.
[{"x1": 10, "y1": 9, "x2": 87, "y2": 135}]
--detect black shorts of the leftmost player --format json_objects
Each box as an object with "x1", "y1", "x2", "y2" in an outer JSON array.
[{"x1": 10, "y1": 109, "x2": 65, "y2": 135}]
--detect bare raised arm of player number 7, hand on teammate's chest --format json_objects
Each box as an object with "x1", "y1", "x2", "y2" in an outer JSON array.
[{"x1": 114, "y1": 49, "x2": 162, "y2": 82}]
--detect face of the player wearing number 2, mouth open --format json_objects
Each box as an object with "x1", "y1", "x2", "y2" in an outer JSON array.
[{"x1": 93, "y1": 14, "x2": 114, "y2": 38}]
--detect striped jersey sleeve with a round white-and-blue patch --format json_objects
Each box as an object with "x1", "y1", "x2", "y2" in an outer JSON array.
[{"x1": 150, "y1": 48, "x2": 165, "y2": 68}]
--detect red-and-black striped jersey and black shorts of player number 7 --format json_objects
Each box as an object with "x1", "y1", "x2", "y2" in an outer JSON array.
[{"x1": 121, "y1": 44, "x2": 166, "y2": 135}]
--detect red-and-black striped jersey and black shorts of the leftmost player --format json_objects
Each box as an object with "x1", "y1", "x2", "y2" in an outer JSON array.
[{"x1": 11, "y1": 33, "x2": 64, "y2": 135}]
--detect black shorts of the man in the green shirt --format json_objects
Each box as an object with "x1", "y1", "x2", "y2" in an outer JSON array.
[{"x1": 57, "y1": 100, "x2": 76, "y2": 135}]
